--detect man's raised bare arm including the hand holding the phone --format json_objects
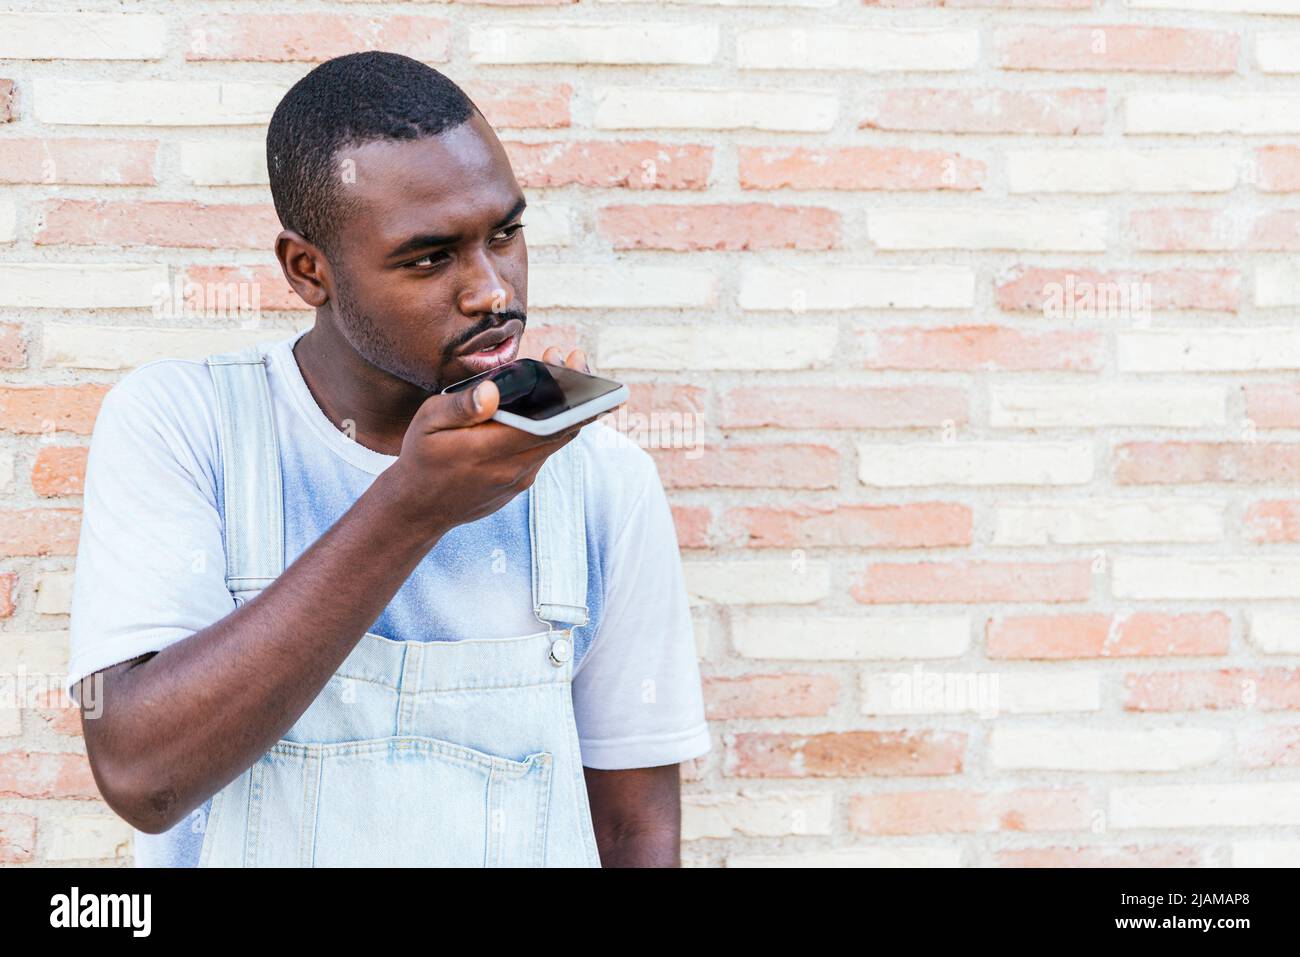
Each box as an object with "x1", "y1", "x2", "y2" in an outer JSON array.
[{"x1": 81, "y1": 369, "x2": 585, "y2": 833}]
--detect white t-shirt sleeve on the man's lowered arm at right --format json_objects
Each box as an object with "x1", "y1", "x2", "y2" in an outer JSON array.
[{"x1": 573, "y1": 452, "x2": 710, "y2": 770}]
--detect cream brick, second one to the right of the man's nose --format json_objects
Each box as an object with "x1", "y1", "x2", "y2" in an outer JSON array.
[{"x1": 740, "y1": 265, "x2": 975, "y2": 312}]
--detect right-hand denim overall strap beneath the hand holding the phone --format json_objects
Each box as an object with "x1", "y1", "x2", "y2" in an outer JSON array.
[{"x1": 528, "y1": 439, "x2": 588, "y2": 625}]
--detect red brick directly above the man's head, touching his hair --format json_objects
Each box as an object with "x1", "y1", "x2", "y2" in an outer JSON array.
[{"x1": 185, "y1": 12, "x2": 451, "y2": 62}]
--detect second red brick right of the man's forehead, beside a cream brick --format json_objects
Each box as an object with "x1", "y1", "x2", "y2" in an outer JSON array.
[{"x1": 738, "y1": 146, "x2": 985, "y2": 190}]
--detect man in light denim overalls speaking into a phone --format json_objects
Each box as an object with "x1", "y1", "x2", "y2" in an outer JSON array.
[{"x1": 69, "y1": 53, "x2": 710, "y2": 866}]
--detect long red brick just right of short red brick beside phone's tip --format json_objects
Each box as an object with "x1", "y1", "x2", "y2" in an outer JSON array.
[{"x1": 718, "y1": 386, "x2": 970, "y2": 429}]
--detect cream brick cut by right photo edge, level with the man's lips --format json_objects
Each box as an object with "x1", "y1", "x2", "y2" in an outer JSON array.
[{"x1": 1115, "y1": 326, "x2": 1300, "y2": 372}]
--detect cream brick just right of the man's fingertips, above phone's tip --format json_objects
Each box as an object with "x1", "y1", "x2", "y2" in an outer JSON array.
[{"x1": 597, "y1": 324, "x2": 837, "y2": 372}]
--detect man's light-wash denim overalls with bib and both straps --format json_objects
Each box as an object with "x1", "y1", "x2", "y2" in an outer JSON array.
[{"x1": 199, "y1": 346, "x2": 601, "y2": 867}]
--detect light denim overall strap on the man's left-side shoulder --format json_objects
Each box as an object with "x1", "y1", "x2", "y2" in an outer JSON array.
[{"x1": 205, "y1": 346, "x2": 285, "y2": 605}]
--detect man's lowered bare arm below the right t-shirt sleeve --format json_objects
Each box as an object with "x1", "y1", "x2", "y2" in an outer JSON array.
[{"x1": 582, "y1": 765, "x2": 681, "y2": 867}]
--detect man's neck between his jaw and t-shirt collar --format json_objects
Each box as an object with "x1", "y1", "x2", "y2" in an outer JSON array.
[{"x1": 294, "y1": 319, "x2": 426, "y2": 455}]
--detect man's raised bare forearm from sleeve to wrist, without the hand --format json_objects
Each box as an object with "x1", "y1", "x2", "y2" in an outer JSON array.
[{"x1": 83, "y1": 473, "x2": 438, "y2": 832}]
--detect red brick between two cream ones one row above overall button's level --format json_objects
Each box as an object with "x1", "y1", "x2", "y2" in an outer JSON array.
[{"x1": 849, "y1": 562, "x2": 1092, "y2": 605}]
